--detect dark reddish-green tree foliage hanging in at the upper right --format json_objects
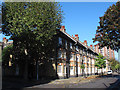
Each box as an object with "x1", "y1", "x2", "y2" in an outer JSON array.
[{"x1": 93, "y1": 1, "x2": 120, "y2": 51}]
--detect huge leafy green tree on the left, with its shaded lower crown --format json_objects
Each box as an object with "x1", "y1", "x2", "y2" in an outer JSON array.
[{"x1": 2, "y1": 2, "x2": 62, "y2": 79}]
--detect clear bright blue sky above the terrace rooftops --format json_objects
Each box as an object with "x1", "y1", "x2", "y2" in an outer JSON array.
[{"x1": 0, "y1": 2, "x2": 118, "y2": 59}]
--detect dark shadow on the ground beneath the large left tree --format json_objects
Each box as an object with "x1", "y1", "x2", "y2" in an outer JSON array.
[{"x1": 2, "y1": 77, "x2": 58, "y2": 90}]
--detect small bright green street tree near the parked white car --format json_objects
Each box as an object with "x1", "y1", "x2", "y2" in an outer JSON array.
[{"x1": 95, "y1": 53, "x2": 106, "y2": 74}]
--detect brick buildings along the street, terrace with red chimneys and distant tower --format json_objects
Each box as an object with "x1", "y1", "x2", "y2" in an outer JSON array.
[{"x1": 3, "y1": 26, "x2": 115, "y2": 78}]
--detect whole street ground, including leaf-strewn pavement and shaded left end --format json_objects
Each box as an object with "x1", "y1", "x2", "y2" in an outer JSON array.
[{"x1": 3, "y1": 73, "x2": 120, "y2": 90}]
